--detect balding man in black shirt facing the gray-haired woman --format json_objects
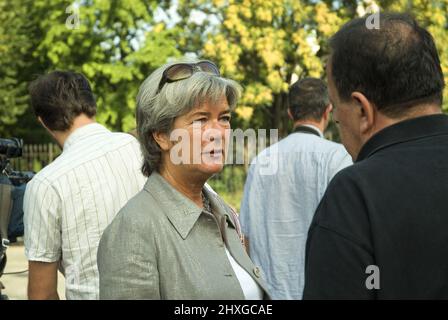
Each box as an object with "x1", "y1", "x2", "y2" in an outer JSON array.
[{"x1": 304, "y1": 14, "x2": 448, "y2": 299}]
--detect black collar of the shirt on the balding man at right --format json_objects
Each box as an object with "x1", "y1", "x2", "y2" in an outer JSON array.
[{"x1": 355, "y1": 114, "x2": 448, "y2": 162}]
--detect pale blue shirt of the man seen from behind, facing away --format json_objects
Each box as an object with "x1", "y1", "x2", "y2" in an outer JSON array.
[{"x1": 240, "y1": 126, "x2": 352, "y2": 299}]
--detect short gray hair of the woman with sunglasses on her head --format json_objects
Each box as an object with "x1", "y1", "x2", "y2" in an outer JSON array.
[{"x1": 136, "y1": 61, "x2": 241, "y2": 176}]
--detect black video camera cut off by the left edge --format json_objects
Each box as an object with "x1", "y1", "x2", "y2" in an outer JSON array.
[{"x1": 0, "y1": 138, "x2": 33, "y2": 300}]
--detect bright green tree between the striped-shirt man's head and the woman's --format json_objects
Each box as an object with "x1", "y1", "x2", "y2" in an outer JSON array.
[{"x1": 32, "y1": 0, "x2": 179, "y2": 131}]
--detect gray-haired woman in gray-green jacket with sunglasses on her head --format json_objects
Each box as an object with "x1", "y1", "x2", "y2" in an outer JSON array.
[{"x1": 98, "y1": 61, "x2": 267, "y2": 299}]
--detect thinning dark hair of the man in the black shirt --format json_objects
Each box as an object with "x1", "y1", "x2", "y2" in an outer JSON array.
[{"x1": 330, "y1": 13, "x2": 444, "y2": 117}]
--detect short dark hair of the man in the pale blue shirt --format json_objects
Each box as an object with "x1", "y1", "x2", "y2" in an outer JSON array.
[{"x1": 288, "y1": 78, "x2": 330, "y2": 121}]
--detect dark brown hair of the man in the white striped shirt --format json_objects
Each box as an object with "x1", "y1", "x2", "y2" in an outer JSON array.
[{"x1": 29, "y1": 71, "x2": 96, "y2": 131}]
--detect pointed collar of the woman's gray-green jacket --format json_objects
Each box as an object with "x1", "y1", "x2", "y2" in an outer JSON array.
[{"x1": 144, "y1": 172, "x2": 236, "y2": 239}]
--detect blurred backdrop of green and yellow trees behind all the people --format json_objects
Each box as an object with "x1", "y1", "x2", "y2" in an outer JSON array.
[{"x1": 0, "y1": 0, "x2": 448, "y2": 209}]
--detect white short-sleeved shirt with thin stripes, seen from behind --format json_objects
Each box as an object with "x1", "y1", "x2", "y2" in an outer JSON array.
[{"x1": 24, "y1": 123, "x2": 146, "y2": 299}]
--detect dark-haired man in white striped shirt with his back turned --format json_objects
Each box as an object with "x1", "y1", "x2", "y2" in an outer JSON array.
[{"x1": 24, "y1": 71, "x2": 146, "y2": 299}]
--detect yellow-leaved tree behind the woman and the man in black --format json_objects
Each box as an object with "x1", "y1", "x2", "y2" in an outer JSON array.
[{"x1": 178, "y1": 0, "x2": 448, "y2": 136}]
